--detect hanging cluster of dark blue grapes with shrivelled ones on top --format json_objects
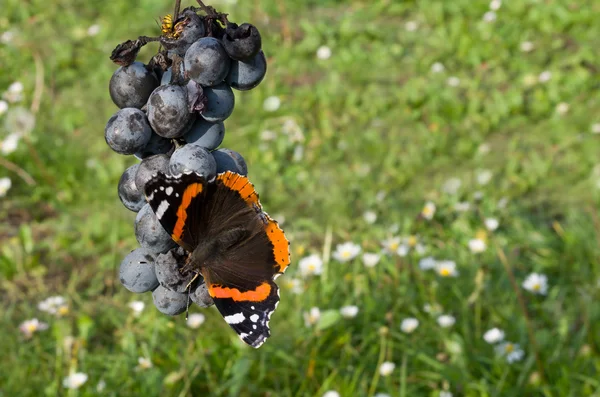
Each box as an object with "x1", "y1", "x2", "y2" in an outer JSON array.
[{"x1": 110, "y1": 1, "x2": 267, "y2": 315}]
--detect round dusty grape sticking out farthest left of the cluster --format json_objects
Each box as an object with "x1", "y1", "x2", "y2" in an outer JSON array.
[{"x1": 104, "y1": 108, "x2": 152, "y2": 154}]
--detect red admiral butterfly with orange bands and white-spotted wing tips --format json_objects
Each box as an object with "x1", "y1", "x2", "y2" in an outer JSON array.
[{"x1": 145, "y1": 171, "x2": 290, "y2": 348}]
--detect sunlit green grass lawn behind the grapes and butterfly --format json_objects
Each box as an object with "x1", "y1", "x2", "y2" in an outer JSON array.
[{"x1": 0, "y1": 0, "x2": 600, "y2": 397}]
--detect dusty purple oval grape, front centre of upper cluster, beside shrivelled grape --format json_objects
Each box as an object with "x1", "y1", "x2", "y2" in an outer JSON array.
[{"x1": 148, "y1": 85, "x2": 196, "y2": 138}]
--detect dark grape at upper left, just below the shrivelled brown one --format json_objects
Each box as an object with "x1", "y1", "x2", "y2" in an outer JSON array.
[{"x1": 108, "y1": 62, "x2": 158, "y2": 109}]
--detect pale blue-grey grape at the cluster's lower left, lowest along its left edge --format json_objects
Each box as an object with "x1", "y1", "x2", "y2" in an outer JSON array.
[{"x1": 119, "y1": 248, "x2": 158, "y2": 293}]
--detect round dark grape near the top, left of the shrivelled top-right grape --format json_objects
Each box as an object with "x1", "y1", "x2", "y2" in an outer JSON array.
[{"x1": 184, "y1": 37, "x2": 231, "y2": 86}]
